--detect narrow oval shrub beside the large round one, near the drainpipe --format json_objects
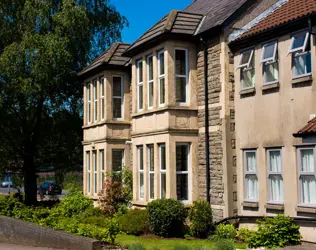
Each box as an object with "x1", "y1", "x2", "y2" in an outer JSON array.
[{"x1": 189, "y1": 201, "x2": 213, "y2": 238}]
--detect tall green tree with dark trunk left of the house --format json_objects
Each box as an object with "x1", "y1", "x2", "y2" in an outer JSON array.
[{"x1": 0, "y1": 0, "x2": 127, "y2": 204}]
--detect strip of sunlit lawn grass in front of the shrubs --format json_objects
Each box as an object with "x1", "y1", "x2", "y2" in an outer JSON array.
[{"x1": 115, "y1": 235, "x2": 246, "y2": 250}]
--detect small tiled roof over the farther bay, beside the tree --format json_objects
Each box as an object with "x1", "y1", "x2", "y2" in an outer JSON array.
[{"x1": 78, "y1": 43, "x2": 130, "y2": 76}]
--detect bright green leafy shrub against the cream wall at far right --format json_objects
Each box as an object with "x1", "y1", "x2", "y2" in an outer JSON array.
[{"x1": 246, "y1": 215, "x2": 302, "y2": 248}]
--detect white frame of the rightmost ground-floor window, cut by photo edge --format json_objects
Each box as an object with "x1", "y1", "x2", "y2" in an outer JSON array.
[{"x1": 297, "y1": 146, "x2": 316, "y2": 207}]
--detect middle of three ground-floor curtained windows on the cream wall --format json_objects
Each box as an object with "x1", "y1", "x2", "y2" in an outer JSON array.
[{"x1": 267, "y1": 149, "x2": 284, "y2": 203}]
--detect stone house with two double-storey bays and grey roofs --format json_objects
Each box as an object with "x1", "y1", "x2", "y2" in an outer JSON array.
[{"x1": 79, "y1": 0, "x2": 279, "y2": 220}]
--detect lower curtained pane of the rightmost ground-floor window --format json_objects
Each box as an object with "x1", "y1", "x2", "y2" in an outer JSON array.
[{"x1": 301, "y1": 176, "x2": 316, "y2": 204}]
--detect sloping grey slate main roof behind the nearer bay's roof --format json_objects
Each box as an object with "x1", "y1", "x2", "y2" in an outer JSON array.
[{"x1": 184, "y1": 0, "x2": 248, "y2": 33}]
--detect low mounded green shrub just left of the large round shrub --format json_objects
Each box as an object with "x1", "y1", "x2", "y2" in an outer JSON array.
[{"x1": 118, "y1": 209, "x2": 149, "y2": 236}]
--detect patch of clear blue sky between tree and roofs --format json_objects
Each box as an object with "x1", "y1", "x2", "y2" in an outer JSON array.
[{"x1": 111, "y1": 0, "x2": 193, "y2": 43}]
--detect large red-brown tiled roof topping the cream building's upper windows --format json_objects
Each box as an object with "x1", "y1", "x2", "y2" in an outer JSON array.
[{"x1": 237, "y1": 0, "x2": 316, "y2": 40}]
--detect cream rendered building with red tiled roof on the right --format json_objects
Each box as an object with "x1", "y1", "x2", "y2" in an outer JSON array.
[{"x1": 230, "y1": 0, "x2": 316, "y2": 242}]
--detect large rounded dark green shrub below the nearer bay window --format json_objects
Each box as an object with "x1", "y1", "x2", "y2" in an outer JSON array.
[{"x1": 147, "y1": 199, "x2": 186, "y2": 237}]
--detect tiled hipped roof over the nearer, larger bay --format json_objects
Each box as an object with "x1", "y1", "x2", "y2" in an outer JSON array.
[{"x1": 126, "y1": 10, "x2": 203, "y2": 55}]
